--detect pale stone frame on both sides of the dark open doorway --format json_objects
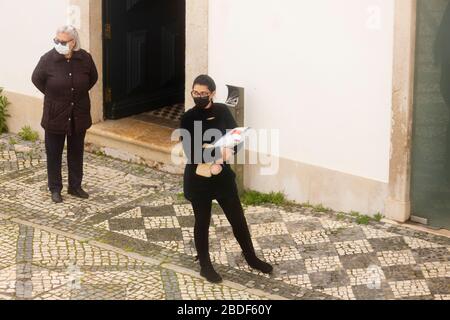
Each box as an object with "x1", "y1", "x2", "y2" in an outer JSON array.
[{"x1": 69, "y1": 0, "x2": 209, "y2": 125}]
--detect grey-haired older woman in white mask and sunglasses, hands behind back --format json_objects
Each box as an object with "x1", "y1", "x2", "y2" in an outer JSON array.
[{"x1": 32, "y1": 26, "x2": 98, "y2": 203}]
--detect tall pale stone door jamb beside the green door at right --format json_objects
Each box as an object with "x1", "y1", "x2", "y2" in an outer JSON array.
[{"x1": 385, "y1": 0, "x2": 417, "y2": 222}]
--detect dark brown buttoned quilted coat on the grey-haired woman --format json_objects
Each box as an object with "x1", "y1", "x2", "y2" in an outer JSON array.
[{"x1": 32, "y1": 49, "x2": 98, "y2": 134}]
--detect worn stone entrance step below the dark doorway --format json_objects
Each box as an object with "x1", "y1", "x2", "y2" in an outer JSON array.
[{"x1": 86, "y1": 118, "x2": 185, "y2": 174}]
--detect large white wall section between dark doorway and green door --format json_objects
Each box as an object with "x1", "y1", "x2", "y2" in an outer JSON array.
[{"x1": 209, "y1": 0, "x2": 394, "y2": 182}]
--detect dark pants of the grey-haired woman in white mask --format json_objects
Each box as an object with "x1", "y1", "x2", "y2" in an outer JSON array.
[{"x1": 45, "y1": 131, "x2": 86, "y2": 192}]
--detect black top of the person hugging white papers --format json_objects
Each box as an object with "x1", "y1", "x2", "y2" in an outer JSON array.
[{"x1": 180, "y1": 103, "x2": 238, "y2": 201}]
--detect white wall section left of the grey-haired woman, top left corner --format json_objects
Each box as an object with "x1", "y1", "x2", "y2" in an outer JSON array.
[{"x1": 0, "y1": 0, "x2": 69, "y2": 97}]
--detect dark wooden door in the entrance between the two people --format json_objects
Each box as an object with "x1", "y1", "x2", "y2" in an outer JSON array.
[{"x1": 103, "y1": 0, "x2": 185, "y2": 119}]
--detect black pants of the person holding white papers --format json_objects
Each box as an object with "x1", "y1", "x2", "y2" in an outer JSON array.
[{"x1": 192, "y1": 194, "x2": 256, "y2": 265}]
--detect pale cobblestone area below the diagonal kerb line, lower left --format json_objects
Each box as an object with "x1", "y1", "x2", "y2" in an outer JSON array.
[{"x1": 0, "y1": 220, "x2": 274, "y2": 300}]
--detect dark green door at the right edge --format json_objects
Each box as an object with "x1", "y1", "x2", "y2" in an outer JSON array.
[{"x1": 411, "y1": 0, "x2": 450, "y2": 229}]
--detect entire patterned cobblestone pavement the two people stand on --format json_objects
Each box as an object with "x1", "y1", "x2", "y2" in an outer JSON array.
[{"x1": 0, "y1": 135, "x2": 450, "y2": 299}]
